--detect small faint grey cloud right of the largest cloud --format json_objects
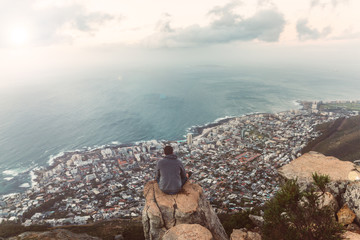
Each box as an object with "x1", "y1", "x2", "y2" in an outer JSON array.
[{"x1": 296, "y1": 19, "x2": 332, "y2": 40}]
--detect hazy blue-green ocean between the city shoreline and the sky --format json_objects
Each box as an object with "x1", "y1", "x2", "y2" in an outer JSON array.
[{"x1": 0, "y1": 65, "x2": 360, "y2": 194}]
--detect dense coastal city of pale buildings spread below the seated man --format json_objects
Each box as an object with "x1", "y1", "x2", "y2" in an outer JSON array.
[{"x1": 0, "y1": 102, "x2": 359, "y2": 226}]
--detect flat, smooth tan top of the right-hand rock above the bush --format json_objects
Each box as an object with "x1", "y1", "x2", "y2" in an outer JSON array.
[{"x1": 278, "y1": 152, "x2": 360, "y2": 182}]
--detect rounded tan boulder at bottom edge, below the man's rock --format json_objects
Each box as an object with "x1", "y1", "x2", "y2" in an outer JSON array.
[{"x1": 162, "y1": 224, "x2": 213, "y2": 240}]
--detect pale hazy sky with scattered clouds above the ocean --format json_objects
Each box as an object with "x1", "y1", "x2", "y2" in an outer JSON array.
[{"x1": 0, "y1": 0, "x2": 360, "y2": 87}]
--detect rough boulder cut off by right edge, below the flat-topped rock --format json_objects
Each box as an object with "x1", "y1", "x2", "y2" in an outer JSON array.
[{"x1": 343, "y1": 181, "x2": 360, "y2": 222}]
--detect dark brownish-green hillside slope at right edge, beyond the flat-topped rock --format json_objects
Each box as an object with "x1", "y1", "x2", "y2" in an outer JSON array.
[{"x1": 302, "y1": 115, "x2": 360, "y2": 161}]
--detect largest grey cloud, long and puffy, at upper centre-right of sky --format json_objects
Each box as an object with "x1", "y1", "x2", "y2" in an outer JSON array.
[{"x1": 146, "y1": 2, "x2": 285, "y2": 47}]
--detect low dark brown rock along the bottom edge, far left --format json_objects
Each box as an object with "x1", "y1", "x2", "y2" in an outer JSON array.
[{"x1": 9, "y1": 229, "x2": 100, "y2": 240}]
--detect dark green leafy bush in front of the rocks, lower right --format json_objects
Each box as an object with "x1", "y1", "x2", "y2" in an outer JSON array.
[{"x1": 262, "y1": 173, "x2": 344, "y2": 240}]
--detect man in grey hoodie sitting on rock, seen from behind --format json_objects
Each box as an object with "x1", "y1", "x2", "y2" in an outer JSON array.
[{"x1": 155, "y1": 146, "x2": 187, "y2": 195}]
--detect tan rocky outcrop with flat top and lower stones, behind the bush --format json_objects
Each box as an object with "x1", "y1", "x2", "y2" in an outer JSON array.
[{"x1": 279, "y1": 152, "x2": 360, "y2": 224}]
